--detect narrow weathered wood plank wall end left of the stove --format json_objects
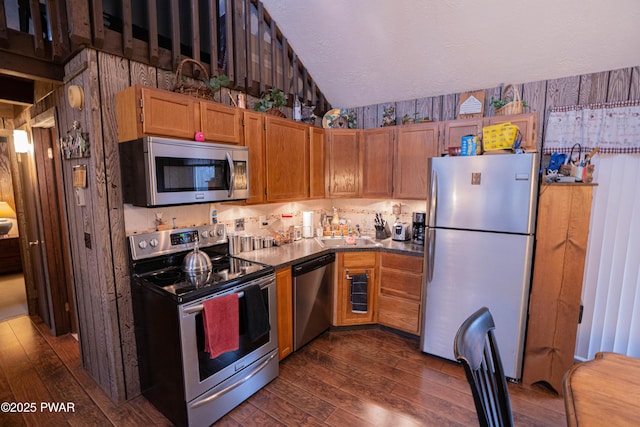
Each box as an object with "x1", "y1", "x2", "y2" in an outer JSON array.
[{"x1": 56, "y1": 49, "x2": 131, "y2": 402}]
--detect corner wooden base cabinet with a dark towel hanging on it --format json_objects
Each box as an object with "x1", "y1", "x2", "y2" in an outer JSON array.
[{"x1": 334, "y1": 252, "x2": 378, "y2": 326}]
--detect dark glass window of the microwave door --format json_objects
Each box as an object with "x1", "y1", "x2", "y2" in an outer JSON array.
[{"x1": 155, "y1": 157, "x2": 230, "y2": 193}]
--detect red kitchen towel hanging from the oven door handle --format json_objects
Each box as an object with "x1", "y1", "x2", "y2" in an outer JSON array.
[{"x1": 202, "y1": 294, "x2": 240, "y2": 359}]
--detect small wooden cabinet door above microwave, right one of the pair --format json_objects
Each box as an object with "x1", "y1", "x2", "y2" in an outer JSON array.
[{"x1": 200, "y1": 101, "x2": 242, "y2": 145}]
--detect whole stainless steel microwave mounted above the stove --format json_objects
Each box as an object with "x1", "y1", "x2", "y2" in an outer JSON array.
[{"x1": 119, "y1": 136, "x2": 249, "y2": 207}]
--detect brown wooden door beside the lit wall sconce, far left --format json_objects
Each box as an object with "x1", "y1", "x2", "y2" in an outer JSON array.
[{"x1": 3, "y1": 129, "x2": 77, "y2": 335}]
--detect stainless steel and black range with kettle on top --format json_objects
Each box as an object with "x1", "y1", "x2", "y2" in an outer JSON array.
[{"x1": 129, "y1": 224, "x2": 278, "y2": 426}]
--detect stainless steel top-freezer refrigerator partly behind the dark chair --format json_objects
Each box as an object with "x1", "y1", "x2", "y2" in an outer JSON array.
[{"x1": 421, "y1": 153, "x2": 539, "y2": 380}]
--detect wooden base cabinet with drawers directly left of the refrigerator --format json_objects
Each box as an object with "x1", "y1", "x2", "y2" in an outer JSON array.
[{"x1": 378, "y1": 252, "x2": 424, "y2": 335}]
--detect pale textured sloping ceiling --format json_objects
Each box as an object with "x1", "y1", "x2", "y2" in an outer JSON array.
[{"x1": 262, "y1": 0, "x2": 640, "y2": 108}]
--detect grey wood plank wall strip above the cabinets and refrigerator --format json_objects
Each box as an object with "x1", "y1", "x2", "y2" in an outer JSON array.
[{"x1": 349, "y1": 66, "x2": 640, "y2": 150}]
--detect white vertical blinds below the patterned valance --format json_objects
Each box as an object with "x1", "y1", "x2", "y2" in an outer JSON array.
[{"x1": 576, "y1": 154, "x2": 640, "y2": 360}]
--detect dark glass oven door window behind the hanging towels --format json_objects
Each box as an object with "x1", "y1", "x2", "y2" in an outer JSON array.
[{"x1": 195, "y1": 288, "x2": 270, "y2": 381}]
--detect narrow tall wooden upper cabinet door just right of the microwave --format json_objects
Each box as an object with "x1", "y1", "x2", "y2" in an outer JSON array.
[{"x1": 242, "y1": 111, "x2": 267, "y2": 204}]
